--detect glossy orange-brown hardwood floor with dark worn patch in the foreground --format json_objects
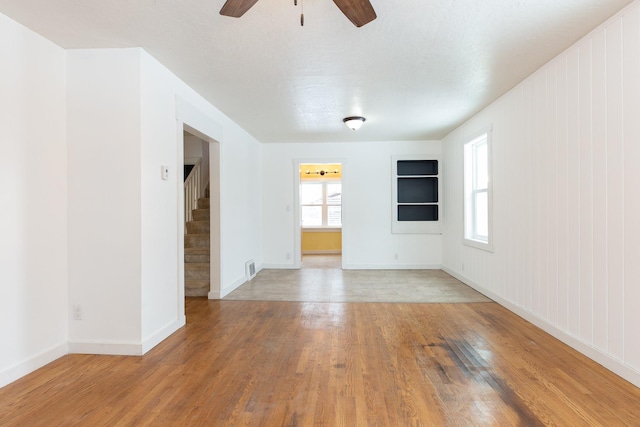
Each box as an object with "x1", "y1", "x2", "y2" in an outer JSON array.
[{"x1": 0, "y1": 299, "x2": 640, "y2": 426}]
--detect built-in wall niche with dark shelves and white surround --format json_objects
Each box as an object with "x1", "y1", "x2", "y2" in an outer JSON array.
[{"x1": 391, "y1": 156, "x2": 441, "y2": 234}]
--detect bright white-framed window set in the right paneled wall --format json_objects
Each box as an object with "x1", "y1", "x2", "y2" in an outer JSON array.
[{"x1": 464, "y1": 132, "x2": 492, "y2": 250}]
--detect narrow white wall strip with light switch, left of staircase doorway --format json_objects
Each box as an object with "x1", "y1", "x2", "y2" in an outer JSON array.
[{"x1": 138, "y1": 50, "x2": 185, "y2": 351}]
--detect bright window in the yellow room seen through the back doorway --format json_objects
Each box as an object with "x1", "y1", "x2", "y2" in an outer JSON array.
[{"x1": 300, "y1": 181, "x2": 342, "y2": 228}]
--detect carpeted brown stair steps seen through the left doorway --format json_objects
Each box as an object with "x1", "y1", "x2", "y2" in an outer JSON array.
[{"x1": 184, "y1": 198, "x2": 211, "y2": 297}]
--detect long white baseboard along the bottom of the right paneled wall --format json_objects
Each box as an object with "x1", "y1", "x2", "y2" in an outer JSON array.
[{"x1": 442, "y1": 267, "x2": 640, "y2": 387}]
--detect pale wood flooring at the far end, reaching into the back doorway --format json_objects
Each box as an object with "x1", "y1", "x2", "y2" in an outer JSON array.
[{"x1": 225, "y1": 255, "x2": 490, "y2": 303}]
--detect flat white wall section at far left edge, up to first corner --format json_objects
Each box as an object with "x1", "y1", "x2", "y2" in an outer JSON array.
[{"x1": 0, "y1": 15, "x2": 68, "y2": 387}]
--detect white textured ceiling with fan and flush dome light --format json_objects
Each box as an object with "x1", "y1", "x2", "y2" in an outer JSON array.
[{"x1": 0, "y1": 0, "x2": 631, "y2": 142}]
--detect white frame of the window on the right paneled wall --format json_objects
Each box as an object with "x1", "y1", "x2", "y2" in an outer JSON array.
[{"x1": 463, "y1": 128, "x2": 493, "y2": 252}]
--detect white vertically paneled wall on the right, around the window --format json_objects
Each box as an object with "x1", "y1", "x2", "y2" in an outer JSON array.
[{"x1": 443, "y1": 2, "x2": 640, "y2": 385}]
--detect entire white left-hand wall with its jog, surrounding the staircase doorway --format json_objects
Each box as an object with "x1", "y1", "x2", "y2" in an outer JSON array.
[{"x1": 0, "y1": 32, "x2": 261, "y2": 386}]
